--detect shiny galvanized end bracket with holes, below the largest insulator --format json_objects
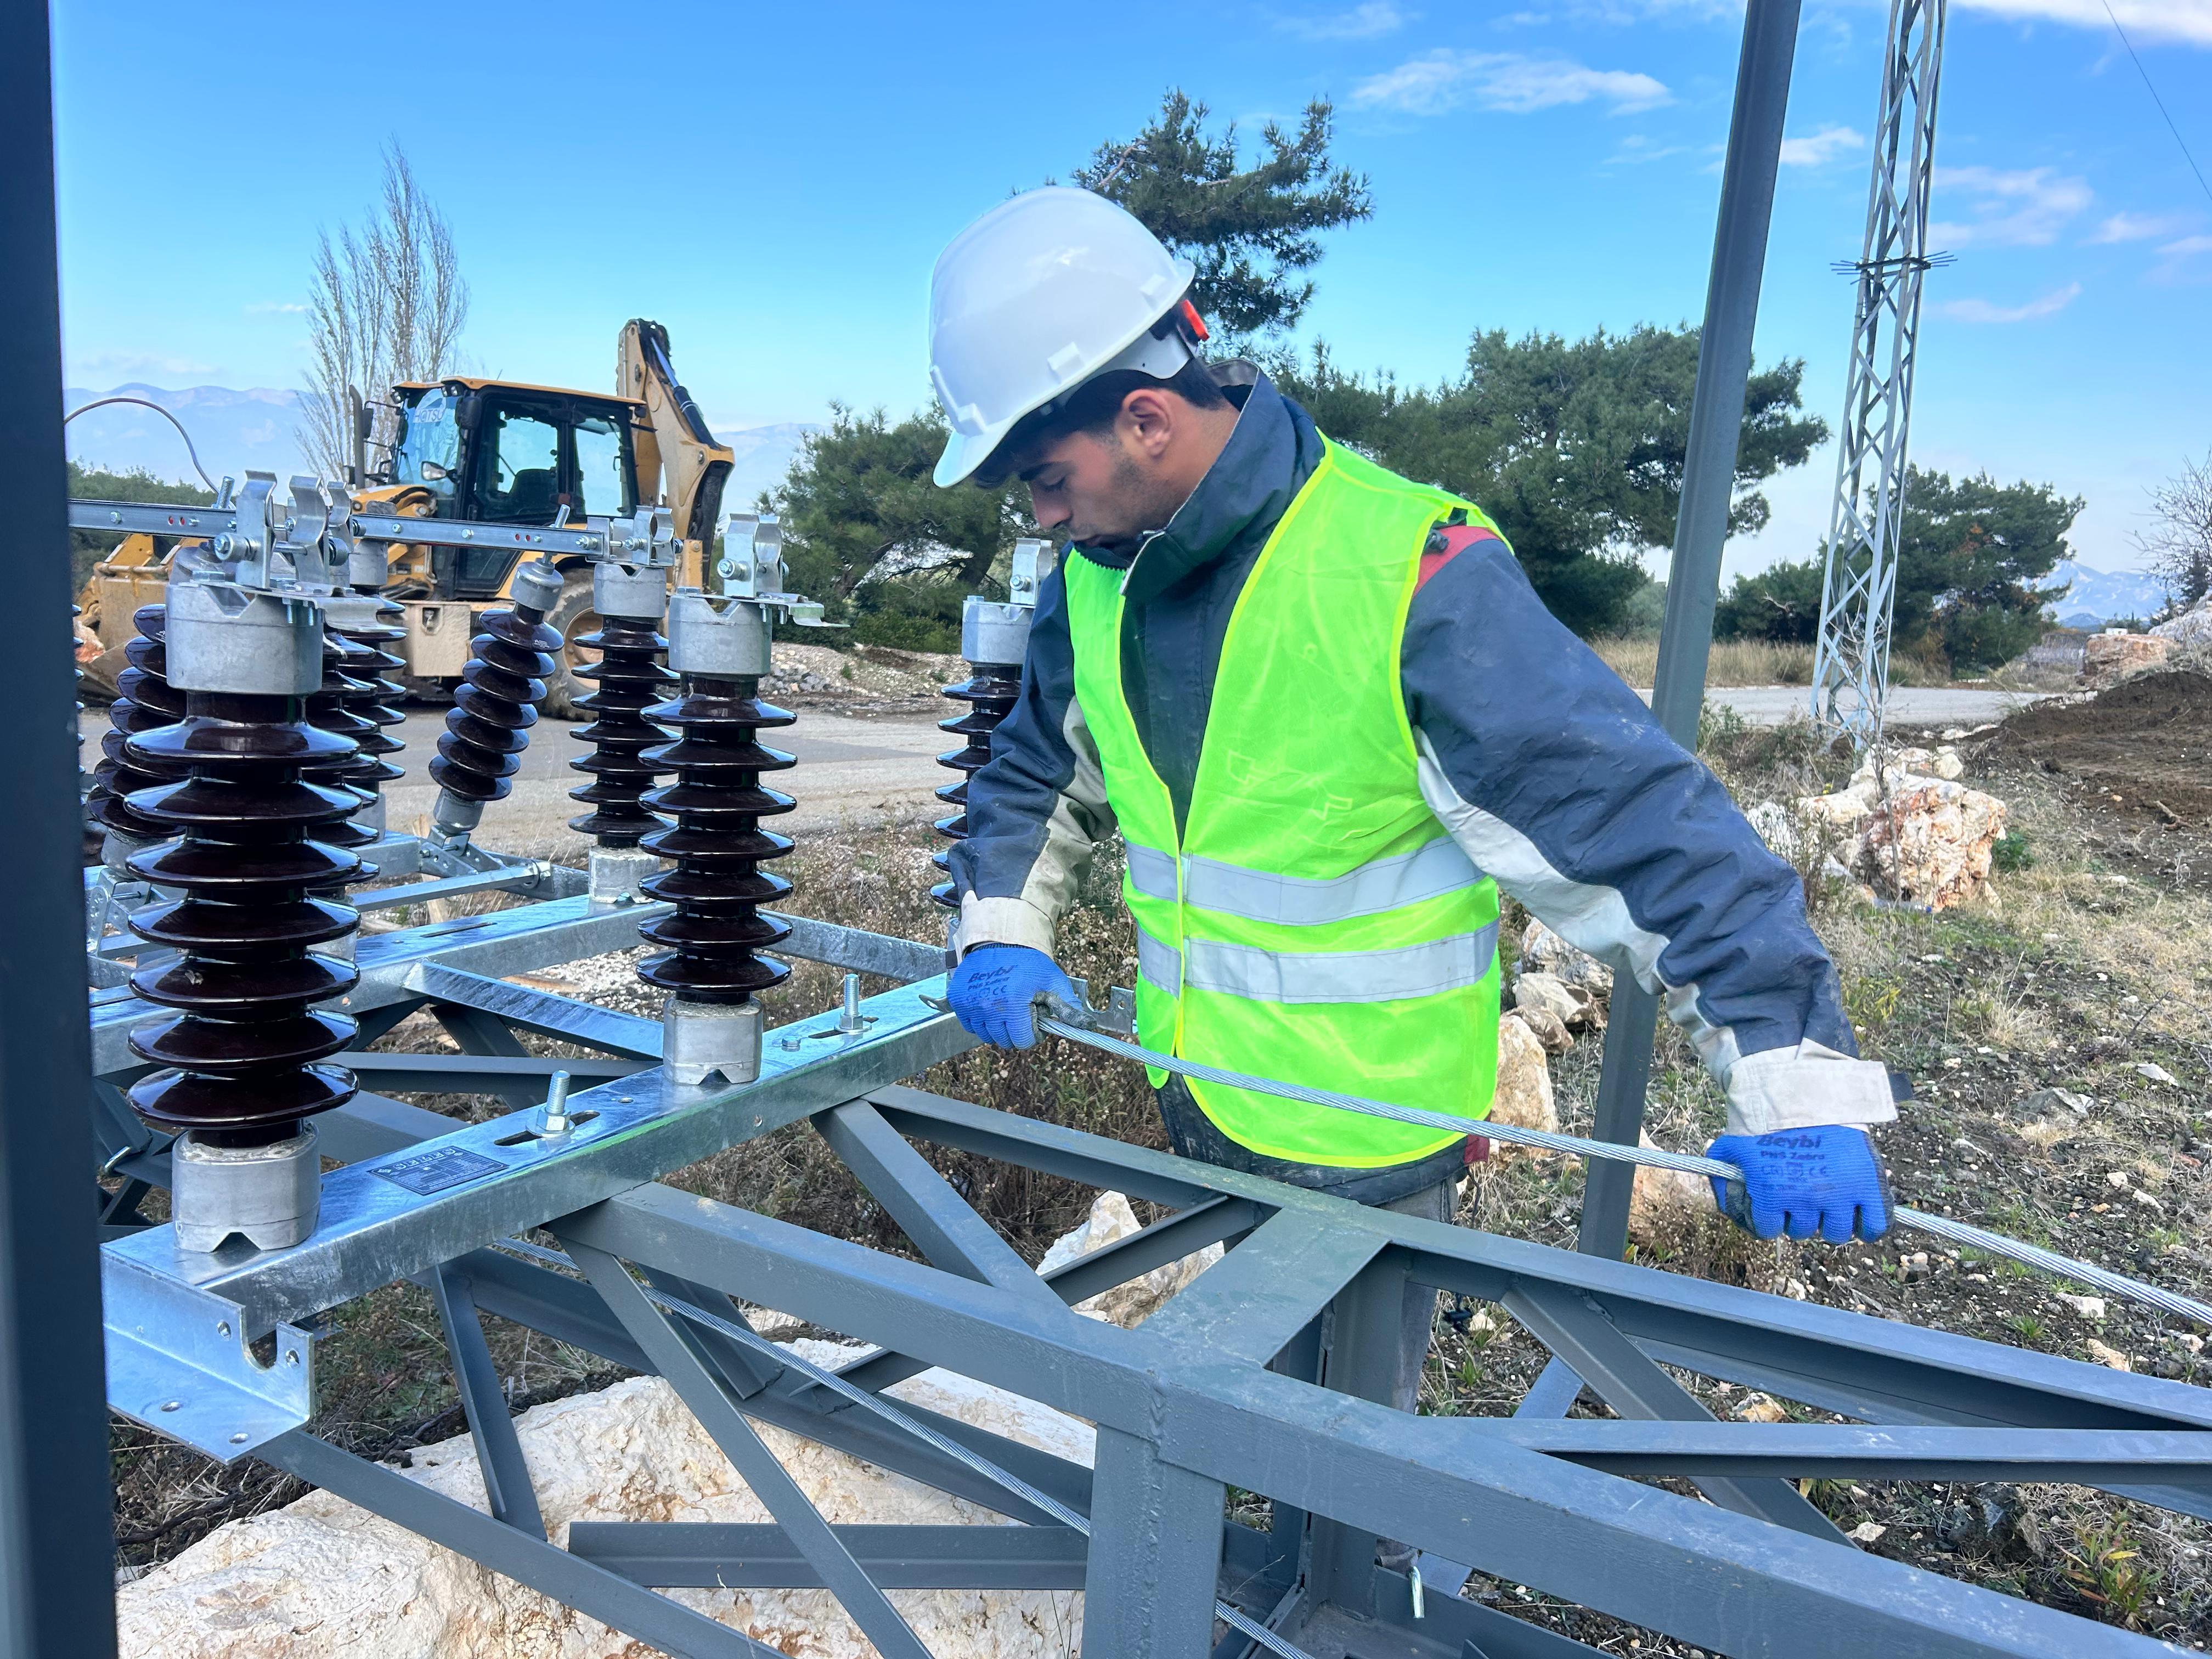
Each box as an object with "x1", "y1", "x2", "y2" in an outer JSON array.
[{"x1": 99, "y1": 1252, "x2": 314, "y2": 1462}]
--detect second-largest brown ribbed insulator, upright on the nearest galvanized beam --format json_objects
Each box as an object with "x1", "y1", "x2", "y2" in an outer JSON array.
[{"x1": 637, "y1": 675, "x2": 797, "y2": 1007}]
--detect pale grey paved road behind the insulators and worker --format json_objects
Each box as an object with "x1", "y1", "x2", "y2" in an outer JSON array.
[{"x1": 84, "y1": 686, "x2": 2033, "y2": 851}]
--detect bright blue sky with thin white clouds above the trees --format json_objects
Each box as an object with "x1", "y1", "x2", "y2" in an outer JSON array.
[{"x1": 55, "y1": 0, "x2": 2212, "y2": 568}]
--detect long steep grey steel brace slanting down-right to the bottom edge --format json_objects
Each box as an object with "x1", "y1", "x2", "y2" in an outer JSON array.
[{"x1": 555, "y1": 1228, "x2": 929, "y2": 1659}]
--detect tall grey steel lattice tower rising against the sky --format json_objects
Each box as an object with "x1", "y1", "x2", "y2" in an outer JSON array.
[{"x1": 1812, "y1": 0, "x2": 1946, "y2": 750}]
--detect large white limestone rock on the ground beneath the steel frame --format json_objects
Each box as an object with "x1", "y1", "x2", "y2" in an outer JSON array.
[{"x1": 115, "y1": 1342, "x2": 1093, "y2": 1659}]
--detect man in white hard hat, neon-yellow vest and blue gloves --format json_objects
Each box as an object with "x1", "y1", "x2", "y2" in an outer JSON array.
[{"x1": 929, "y1": 188, "x2": 1895, "y2": 1407}]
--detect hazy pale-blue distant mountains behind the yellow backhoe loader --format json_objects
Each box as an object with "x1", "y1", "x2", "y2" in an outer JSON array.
[{"x1": 62, "y1": 381, "x2": 819, "y2": 509}]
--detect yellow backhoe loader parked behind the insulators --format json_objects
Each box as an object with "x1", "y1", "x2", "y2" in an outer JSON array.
[{"x1": 73, "y1": 319, "x2": 735, "y2": 714}]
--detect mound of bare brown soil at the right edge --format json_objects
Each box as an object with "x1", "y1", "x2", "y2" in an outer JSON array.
[{"x1": 1991, "y1": 670, "x2": 2212, "y2": 825}]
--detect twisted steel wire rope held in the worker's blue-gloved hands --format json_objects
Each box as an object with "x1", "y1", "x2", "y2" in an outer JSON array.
[{"x1": 1037, "y1": 1015, "x2": 2212, "y2": 1325}]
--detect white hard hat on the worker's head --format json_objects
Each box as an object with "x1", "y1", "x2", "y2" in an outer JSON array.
[{"x1": 929, "y1": 186, "x2": 1192, "y2": 484}]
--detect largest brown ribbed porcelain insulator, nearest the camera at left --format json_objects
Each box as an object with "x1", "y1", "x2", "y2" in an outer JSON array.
[{"x1": 131, "y1": 692, "x2": 360, "y2": 1146}]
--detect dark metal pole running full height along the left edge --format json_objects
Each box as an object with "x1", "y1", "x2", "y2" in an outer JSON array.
[{"x1": 0, "y1": 0, "x2": 115, "y2": 1659}]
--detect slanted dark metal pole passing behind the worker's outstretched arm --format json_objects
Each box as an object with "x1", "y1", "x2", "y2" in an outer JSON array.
[{"x1": 1579, "y1": 0, "x2": 1798, "y2": 1256}]
